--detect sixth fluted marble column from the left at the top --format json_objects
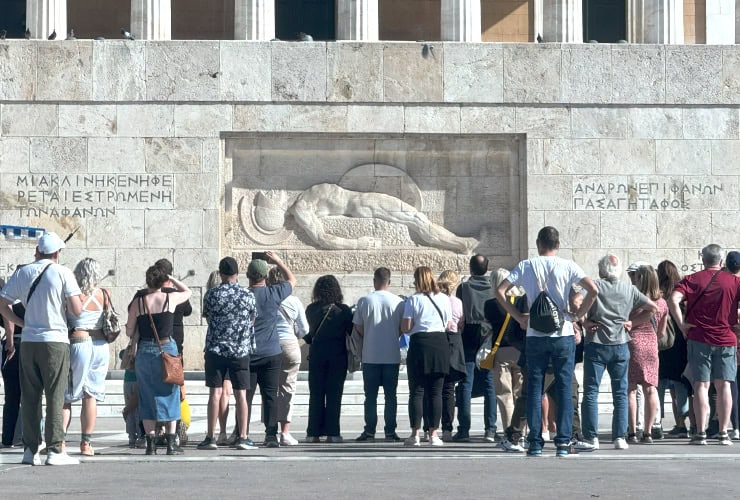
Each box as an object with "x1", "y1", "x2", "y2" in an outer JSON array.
[{"x1": 533, "y1": 0, "x2": 583, "y2": 43}]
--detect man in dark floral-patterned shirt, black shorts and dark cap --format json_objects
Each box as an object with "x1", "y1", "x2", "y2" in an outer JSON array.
[{"x1": 198, "y1": 257, "x2": 257, "y2": 450}]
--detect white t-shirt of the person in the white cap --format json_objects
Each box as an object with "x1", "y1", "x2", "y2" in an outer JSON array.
[{"x1": 0, "y1": 259, "x2": 82, "y2": 344}]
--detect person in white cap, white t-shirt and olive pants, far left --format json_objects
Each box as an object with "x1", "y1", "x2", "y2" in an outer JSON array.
[{"x1": 0, "y1": 233, "x2": 82, "y2": 465}]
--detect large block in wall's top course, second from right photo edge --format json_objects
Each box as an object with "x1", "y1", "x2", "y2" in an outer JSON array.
[{"x1": 666, "y1": 45, "x2": 722, "y2": 104}]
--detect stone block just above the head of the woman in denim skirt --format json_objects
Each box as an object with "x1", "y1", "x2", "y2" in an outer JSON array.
[{"x1": 144, "y1": 210, "x2": 203, "y2": 248}]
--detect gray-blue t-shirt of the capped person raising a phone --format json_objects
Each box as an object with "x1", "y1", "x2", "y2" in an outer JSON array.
[{"x1": 251, "y1": 283, "x2": 293, "y2": 360}]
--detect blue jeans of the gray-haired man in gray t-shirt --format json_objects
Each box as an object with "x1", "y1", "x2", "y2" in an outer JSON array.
[{"x1": 581, "y1": 342, "x2": 628, "y2": 440}]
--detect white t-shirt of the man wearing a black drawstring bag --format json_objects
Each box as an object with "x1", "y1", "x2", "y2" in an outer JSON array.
[{"x1": 506, "y1": 255, "x2": 586, "y2": 337}]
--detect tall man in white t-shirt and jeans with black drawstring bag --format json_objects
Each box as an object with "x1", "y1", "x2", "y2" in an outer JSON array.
[{"x1": 496, "y1": 226, "x2": 598, "y2": 456}]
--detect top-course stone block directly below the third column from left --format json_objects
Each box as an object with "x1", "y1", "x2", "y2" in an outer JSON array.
[{"x1": 218, "y1": 40, "x2": 272, "y2": 101}]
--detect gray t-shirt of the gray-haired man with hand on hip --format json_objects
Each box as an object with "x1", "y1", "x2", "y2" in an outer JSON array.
[{"x1": 585, "y1": 278, "x2": 649, "y2": 345}]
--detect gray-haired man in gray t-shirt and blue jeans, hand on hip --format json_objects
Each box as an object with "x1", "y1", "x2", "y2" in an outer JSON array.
[{"x1": 578, "y1": 255, "x2": 658, "y2": 451}]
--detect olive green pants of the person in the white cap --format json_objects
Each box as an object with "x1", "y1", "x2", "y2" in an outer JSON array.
[{"x1": 20, "y1": 342, "x2": 69, "y2": 453}]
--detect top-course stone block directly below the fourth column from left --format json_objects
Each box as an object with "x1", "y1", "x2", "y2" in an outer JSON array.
[{"x1": 326, "y1": 42, "x2": 383, "y2": 102}]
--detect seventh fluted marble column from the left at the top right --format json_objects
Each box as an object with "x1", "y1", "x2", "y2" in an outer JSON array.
[{"x1": 627, "y1": 0, "x2": 684, "y2": 44}]
